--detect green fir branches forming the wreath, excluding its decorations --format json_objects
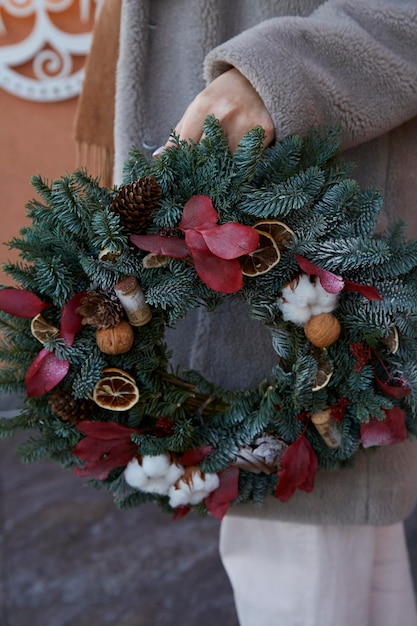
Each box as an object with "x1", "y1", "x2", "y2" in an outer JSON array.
[{"x1": 0, "y1": 116, "x2": 417, "y2": 514}]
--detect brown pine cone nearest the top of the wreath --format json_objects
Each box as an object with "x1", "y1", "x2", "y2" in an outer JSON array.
[{"x1": 110, "y1": 176, "x2": 162, "y2": 234}]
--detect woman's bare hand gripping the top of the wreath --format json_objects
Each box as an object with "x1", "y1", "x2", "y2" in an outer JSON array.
[{"x1": 158, "y1": 69, "x2": 275, "y2": 152}]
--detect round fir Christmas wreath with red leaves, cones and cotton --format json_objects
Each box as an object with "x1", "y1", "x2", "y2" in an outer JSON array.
[{"x1": 0, "y1": 118, "x2": 417, "y2": 518}]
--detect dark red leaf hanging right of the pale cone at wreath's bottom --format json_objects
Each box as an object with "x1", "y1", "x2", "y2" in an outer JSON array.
[{"x1": 275, "y1": 435, "x2": 318, "y2": 502}]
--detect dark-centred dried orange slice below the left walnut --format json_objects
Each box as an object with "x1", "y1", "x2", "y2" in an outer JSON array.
[{"x1": 93, "y1": 368, "x2": 139, "y2": 411}]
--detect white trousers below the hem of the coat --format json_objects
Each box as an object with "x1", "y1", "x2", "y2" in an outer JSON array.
[{"x1": 220, "y1": 516, "x2": 417, "y2": 626}]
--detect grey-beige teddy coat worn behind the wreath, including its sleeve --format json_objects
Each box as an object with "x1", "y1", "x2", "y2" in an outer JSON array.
[{"x1": 106, "y1": 0, "x2": 417, "y2": 524}]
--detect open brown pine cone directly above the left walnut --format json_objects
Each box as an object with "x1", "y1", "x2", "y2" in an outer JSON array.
[{"x1": 76, "y1": 289, "x2": 123, "y2": 328}]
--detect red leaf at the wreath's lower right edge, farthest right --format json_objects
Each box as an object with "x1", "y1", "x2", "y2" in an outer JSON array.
[{"x1": 361, "y1": 406, "x2": 407, "y2": 448}]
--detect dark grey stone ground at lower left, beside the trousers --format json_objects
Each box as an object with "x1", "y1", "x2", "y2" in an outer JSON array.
[{"x1": 0, "y1": 428, "x2": 237, "y2": 626}]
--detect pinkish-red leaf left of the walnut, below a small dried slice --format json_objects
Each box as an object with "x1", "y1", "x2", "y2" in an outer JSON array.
[{"x1": 25, "y1": 348, "x2": 69, "y2": 398}]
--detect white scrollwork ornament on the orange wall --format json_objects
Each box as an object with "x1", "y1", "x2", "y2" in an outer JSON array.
[{"x1": 0, "y1": 0, "x2": 103, "y2": 102}]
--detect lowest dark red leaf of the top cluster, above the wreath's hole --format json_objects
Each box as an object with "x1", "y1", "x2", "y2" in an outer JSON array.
[{"x1": 191, "y1": 250, "x2": 243, "y2": 293}]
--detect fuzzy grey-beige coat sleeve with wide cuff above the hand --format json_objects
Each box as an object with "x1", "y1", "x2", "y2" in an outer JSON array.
[{"x1": 205, "y1": 0, "x2": 417, "y2": 148}]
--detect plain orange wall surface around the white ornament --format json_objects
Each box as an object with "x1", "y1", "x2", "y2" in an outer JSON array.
[{"x1": 0, "y1": 0, "x2": 93, "y2": 285}]
